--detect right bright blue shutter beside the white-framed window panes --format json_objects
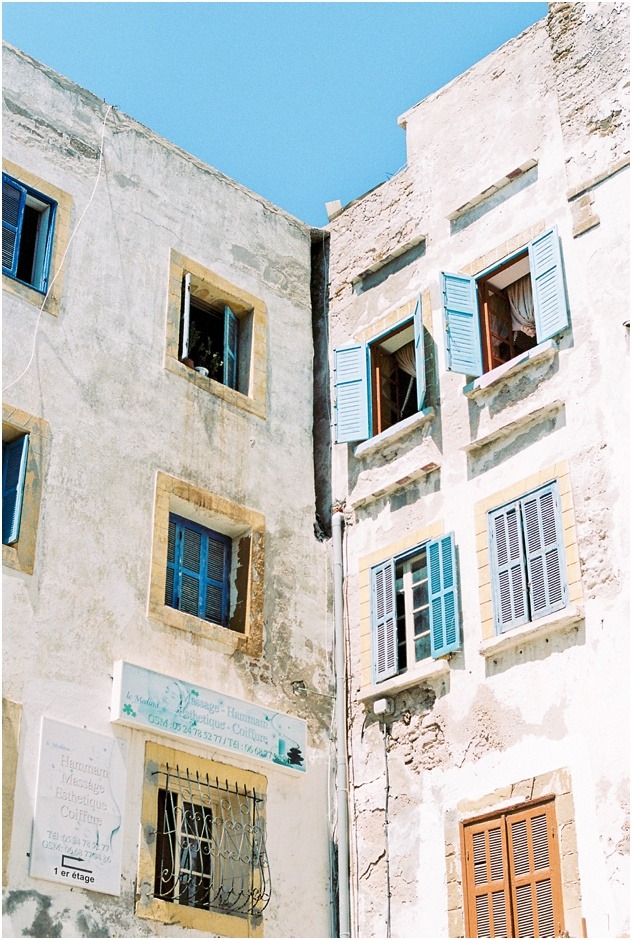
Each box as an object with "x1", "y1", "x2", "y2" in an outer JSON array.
[{"x1": 426, "y1": 532, "x2": 461, "y2": 658}]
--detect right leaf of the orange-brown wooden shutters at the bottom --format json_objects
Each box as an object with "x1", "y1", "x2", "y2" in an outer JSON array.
[{"x1": 507, "y1": 802, "x2": 564, "y2": 937}]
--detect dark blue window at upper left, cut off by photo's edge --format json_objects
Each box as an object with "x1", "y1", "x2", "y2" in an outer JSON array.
[{"x1": 2, "y1": 173, "x2": 57, "y2": 294}]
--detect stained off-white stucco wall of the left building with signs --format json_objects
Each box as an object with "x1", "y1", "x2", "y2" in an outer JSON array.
[{"x1": 3, "y1": 47, "x2": 331, "y2": 936}]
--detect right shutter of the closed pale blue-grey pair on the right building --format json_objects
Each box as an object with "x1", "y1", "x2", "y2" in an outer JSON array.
[{"x1": 520, "y1": 483, "x2": 567, "y2": 620}]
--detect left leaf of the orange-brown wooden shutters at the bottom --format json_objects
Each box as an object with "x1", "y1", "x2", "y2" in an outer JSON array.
[{"x1": 463, "y1": 817, "x2": 513, "y2": 937}]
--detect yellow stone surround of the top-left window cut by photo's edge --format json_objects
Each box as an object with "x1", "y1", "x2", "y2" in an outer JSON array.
[{"x1": 2, "y1": 159, "x2": 73, "y2": 317}]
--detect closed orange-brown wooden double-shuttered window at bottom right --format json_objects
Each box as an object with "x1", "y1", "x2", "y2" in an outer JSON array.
[{"x1": 462, "y1": 798, "x2": 564, "y2": 937}]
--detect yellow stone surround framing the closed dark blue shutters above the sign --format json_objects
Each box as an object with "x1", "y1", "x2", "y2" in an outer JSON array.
[{"x1": 148, "y1": 470, "x2": 265, "y2": 657}]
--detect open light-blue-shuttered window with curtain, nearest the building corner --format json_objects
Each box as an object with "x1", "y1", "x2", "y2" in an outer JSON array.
[{"x1": 334, "y1": 298, "x2": 426, "y2": 443}]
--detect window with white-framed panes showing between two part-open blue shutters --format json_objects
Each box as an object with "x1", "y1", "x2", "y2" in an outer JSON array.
[{"x1": 371, "y1": 534, "x2": 461, "y2": 682}]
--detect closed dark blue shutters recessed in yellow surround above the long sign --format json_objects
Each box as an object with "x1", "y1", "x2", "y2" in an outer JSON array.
[{"x1": 165, "y1": 513, "x2": 231, "y2": 627}]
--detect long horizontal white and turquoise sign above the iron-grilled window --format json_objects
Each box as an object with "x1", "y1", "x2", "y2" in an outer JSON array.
[{"x1": 112, "y1": 662, "x2": 307, "y2": 773}]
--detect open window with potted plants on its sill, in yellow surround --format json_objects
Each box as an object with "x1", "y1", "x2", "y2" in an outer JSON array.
[{"x1": 180, "y1": 273, "x2": 242, "y2": 394}]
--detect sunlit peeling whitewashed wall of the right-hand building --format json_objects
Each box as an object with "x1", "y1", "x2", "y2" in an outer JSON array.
[{"x1": 329, "y1": 4, "x2": 629, "y2": 937}]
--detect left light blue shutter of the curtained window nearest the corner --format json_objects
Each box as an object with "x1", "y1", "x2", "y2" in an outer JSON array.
[{"x1": 334, "y1": 343, "x2": 369, "y2": 444}]
